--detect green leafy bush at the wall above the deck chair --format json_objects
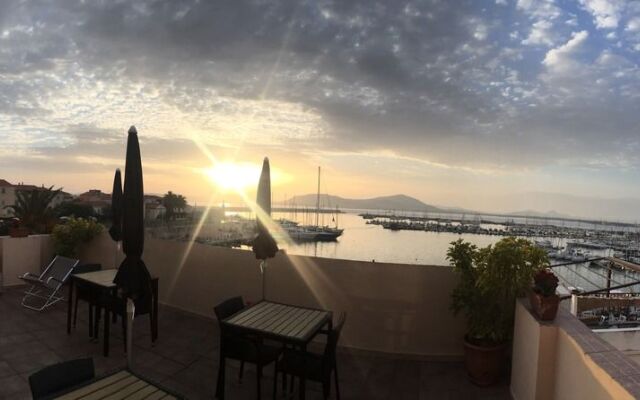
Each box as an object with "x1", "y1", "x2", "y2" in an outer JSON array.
[{"x1": 51, "y1": 218, "x2": 104, "y2": 257}]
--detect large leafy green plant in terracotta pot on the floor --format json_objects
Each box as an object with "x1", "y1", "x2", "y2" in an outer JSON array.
[{"x1": 447, "y1": 237, "x2": 548, "y2": 386}]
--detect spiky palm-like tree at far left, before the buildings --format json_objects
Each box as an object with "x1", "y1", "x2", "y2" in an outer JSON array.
[{"x1": 9, "y1": 186, "x2": 62, "y2": 233}]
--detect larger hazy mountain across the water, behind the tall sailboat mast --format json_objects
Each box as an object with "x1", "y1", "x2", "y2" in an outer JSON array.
[{"x1": 287, "y1": 194, "x2": 443, "y2": 212}]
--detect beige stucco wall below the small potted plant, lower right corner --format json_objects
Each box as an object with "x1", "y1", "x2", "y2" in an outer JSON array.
[{"x1": 511, "y1": 301, "x2": 640, "y2": 400}]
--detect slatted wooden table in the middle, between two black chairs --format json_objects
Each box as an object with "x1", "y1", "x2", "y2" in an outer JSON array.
[{"x1": 221, "y1": 301, "x2": 332, "y2": 399}]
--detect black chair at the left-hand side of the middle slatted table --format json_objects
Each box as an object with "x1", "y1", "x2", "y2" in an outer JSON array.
[{"x1": 214, "y1": 297, "x2": 282, "y2": 399}]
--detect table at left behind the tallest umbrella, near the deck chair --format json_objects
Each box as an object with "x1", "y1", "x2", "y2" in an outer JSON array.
[{"x1": 67, "y1": 269, "x2": 158, "y2": 357}]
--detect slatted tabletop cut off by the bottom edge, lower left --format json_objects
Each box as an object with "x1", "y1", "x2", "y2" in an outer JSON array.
[{"x1": 51, "y1": 370, "x2": 181, "y2": 400}]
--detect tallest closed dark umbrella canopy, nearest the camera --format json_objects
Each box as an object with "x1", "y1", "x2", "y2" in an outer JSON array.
[{"x1": 113, "y1": 126, "x2": 151, "y2": 299}]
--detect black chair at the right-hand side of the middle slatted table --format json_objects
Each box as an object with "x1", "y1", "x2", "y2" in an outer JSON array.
[{"x1": 273, "y1": 313, "x2": 347, "y2": 400}]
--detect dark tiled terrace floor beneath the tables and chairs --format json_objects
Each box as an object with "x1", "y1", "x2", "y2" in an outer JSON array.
[{"x1": 0, "y1": 289, "x2": 510, "y2": 400}]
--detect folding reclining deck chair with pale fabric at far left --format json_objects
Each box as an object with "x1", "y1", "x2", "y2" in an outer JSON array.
[{"x1": 19, "y1": 256, "x2": 79, "y2": 311}]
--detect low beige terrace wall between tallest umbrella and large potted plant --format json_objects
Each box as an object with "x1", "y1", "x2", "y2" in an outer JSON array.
[{"x1": 144, "y1": 239, "x2": 465, "y2": 358}]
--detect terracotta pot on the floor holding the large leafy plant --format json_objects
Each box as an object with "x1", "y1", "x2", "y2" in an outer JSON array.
[{"x1": 464, "y1": 337, "x2": 507, "y2": 386}]
